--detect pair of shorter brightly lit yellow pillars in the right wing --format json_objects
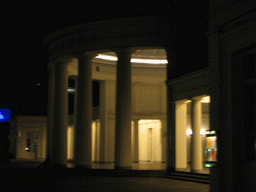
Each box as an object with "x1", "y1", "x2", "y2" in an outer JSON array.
[{"x1": 175, "y1": 96, "x2": 205, "y2": 172}]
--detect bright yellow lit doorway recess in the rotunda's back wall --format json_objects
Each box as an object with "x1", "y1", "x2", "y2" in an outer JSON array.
[{"x1": 139, "y1": 119, "x2": 162, "y2": 161}]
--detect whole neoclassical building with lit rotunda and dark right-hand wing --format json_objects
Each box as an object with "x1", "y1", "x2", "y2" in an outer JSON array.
[{"x1": 8, "y1": 0, "x2": 256, "y2": 192}]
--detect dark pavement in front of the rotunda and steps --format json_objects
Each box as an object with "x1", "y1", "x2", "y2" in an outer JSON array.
[{"x1": 0, "y1": 162, "x2": 209, "y2": 192}]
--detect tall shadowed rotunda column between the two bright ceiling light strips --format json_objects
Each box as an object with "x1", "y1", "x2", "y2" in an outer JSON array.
[{"x1": 115, "y1": 48, "x2": 132, "y2": 169}]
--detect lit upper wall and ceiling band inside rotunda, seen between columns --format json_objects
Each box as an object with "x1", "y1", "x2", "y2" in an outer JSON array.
[{"x1": 69, "y1": 49, "x2": 166, "y2": 83}]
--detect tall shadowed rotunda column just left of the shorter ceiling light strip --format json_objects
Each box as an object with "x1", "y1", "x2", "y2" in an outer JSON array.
[{"x1": 74, "y1": 53, "x2": 95, "y2": 168}]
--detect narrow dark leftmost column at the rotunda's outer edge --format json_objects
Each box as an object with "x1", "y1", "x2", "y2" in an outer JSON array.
[{"x1": 46, "y1": 63, "x2": 55, "y2": 161}]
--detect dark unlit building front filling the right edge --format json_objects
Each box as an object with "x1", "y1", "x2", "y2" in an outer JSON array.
[{"x1": 206, "y1": 0, "x2": 256, "y2": 191}]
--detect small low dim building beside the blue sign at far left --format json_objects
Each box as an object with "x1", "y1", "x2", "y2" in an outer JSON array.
[{"x1": 9, "y1": 115, "x2": 47, "y2": 159}]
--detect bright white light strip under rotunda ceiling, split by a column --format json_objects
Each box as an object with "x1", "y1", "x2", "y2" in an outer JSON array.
[{"x1": 95, "y1": 54, "x2": 168, "y2": 64}]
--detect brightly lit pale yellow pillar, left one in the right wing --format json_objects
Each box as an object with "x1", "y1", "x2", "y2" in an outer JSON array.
[{"x1": 175, "y1": 100, "x2": 187, "y2": 169}]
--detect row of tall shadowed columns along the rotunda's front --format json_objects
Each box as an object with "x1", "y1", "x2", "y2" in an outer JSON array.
[{"x1": 47, "y1": 48, "x2": 134, "y2": 169}]
